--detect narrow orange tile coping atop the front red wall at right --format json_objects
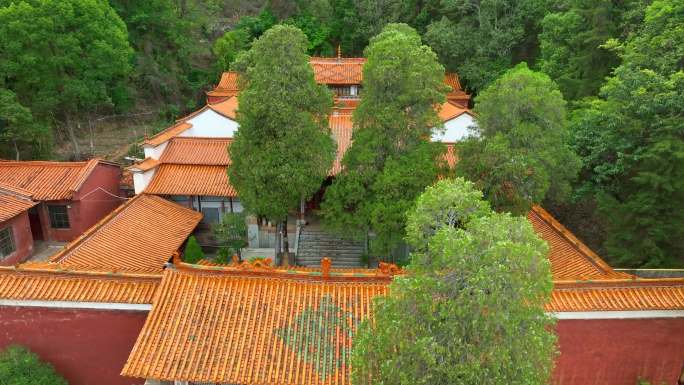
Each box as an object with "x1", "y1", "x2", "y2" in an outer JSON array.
[{"x1": 546, "y1": 278, "x2": 684, "y2": 312}]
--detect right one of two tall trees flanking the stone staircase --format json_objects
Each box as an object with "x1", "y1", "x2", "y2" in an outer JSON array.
[{"x1": 322, "y1": 24, "x2": 445, "y2": 254}]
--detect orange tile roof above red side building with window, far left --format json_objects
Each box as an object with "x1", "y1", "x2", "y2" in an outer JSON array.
[{"x1": 0, "y1": 159, "x2": 105, "y2": 201}]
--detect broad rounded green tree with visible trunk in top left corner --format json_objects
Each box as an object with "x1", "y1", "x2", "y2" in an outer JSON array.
[{"x1": 0, "y1": 0, "x2": 131, "y2": 157}]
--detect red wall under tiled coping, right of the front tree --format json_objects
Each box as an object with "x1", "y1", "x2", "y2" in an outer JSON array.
[{"x1": 554, "y1": 318, "x2": 684, "y2": 385}]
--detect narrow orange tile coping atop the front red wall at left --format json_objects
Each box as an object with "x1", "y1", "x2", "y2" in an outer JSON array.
[{"x1": 0, "y1": 265, "x2": 161, "y2": 304}]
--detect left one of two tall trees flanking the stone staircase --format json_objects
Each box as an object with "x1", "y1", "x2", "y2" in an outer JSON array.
[{"x1": 228, "y1": 25, "x2": 335, "y2": 253}]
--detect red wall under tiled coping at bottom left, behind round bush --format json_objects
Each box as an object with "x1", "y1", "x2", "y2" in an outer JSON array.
[{"x1": 0, "y1": 306, "x2": 147, "y2": 385}]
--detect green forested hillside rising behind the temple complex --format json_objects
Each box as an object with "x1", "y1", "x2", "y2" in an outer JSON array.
[{"x1": 0, "y1": 0, "x2": 684, "y2": 267}]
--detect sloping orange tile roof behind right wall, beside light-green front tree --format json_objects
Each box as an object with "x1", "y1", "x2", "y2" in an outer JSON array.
[{"x1": 527, "y1": 206, "x2": 632, "y2": 280}]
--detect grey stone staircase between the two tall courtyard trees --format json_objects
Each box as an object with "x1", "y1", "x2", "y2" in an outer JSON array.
[{"x1": 297, "y1": 226, "x2": 364, "y2": 268}]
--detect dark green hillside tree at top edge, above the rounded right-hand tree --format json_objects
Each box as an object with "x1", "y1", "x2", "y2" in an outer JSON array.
[{"x1": 539, "y1": 0, "x2": 645, "y2": 100}]
